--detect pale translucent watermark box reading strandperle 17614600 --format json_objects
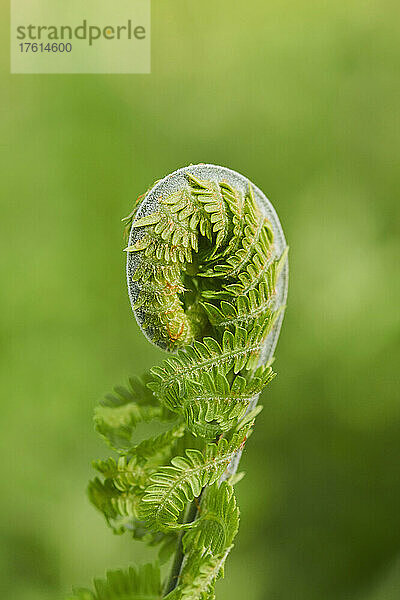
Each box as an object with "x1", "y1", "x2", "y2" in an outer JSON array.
[{"x1": 10, "y1": 0, "x2": 150, "y2": 73}]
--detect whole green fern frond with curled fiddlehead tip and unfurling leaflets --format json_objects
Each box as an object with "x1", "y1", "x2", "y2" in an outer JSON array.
[{"x1": 70, "y1": 165, "x2": 288, "y2": 600}]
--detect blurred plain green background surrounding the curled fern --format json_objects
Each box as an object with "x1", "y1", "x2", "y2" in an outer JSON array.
[{"x1": 0, "y1": 0, "x2": 400, "y2": 600}]
